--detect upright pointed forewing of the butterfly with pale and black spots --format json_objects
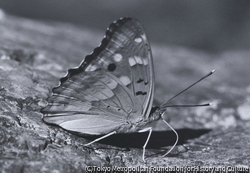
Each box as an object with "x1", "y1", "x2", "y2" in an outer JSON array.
[{"x1": 86, "y1": 18, "x2": 154, "y2": 118}]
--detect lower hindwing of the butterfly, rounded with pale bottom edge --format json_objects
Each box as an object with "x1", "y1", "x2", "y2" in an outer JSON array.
[{"x1": 42, "y1": 69, "x2": 138, "y2": 135}]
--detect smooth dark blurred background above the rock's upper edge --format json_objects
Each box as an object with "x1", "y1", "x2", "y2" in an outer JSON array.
[{"x1": 0, "y1": 0, "x2": 250, "y2": 53}]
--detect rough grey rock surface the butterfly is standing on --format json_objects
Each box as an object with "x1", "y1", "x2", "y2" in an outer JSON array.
[{"x1": 0, "y1": 14, "x2": 250, "y2": 173}]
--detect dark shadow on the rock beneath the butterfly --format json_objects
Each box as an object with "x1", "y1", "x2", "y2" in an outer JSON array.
[{"x1": 84, "y1": 129, "x2": 211, "y2": 149}]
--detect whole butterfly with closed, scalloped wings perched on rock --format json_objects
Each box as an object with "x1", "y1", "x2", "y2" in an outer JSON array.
[{"x1": 41, "y1": 17, "x2": 213, "y2": 161}]
